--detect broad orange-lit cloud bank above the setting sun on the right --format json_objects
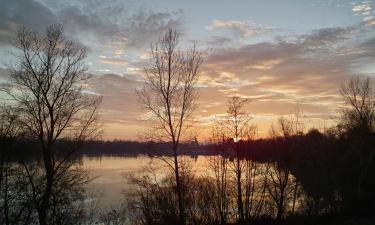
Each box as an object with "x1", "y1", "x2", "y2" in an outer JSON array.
[{"x1": 200, "y1": 24, "x2": 375, "y2": 121}]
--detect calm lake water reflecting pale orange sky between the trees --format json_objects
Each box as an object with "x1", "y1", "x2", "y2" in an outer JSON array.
[{"x1": 83, "y1": 156, "x2": 207, "y2": 207}]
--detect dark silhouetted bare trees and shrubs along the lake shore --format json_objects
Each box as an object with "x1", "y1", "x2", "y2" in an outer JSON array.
[{"x1": 0, "y1": 26, "x2": 375, "y2": 225}]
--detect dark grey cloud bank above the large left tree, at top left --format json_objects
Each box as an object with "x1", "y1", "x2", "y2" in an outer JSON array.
[{"x1": 0, "y1": 0, "x2": 184, "y2": 48}]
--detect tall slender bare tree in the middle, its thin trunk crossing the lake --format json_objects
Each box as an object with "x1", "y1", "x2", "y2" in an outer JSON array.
[{"x1": 138, "y1": 29, "x2": 202, "y2": 224}]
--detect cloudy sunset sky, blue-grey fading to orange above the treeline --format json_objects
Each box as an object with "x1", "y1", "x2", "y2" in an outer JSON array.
[{"x1": 0, "y1": 0, "x2": 375, "y2": 140}]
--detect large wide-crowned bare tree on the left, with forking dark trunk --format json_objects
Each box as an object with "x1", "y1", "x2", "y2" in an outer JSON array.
[{"x1": 6, "y1": 25, "x2": 101, "y2": 225}]
